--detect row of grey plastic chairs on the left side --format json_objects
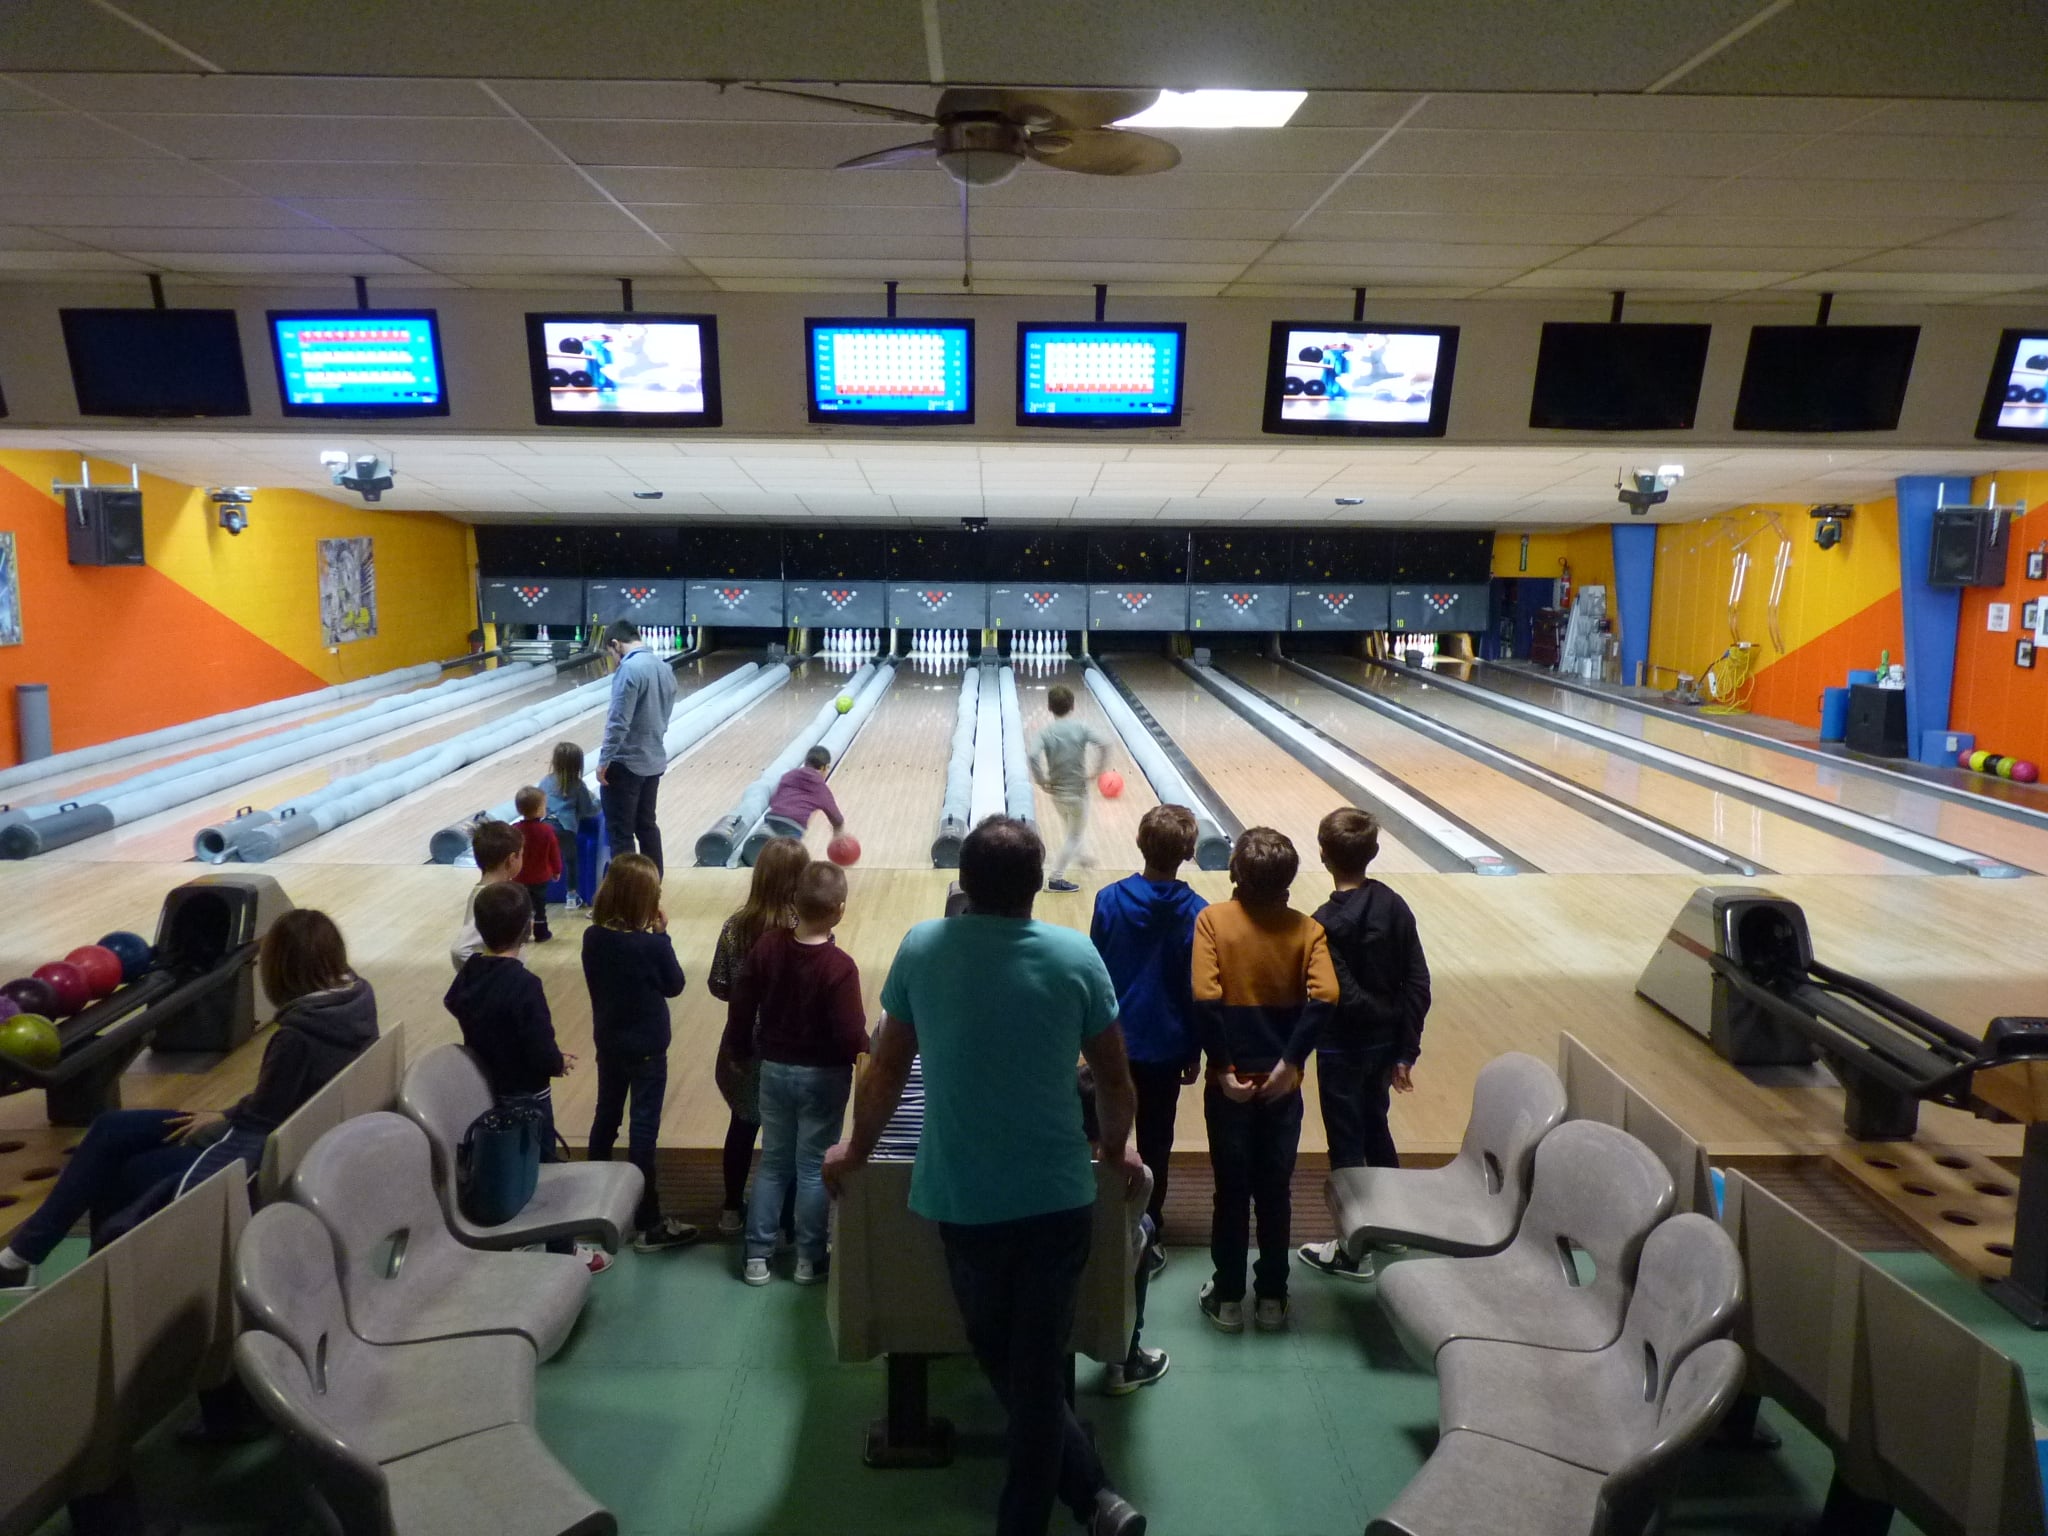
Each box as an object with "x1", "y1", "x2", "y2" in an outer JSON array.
[{"x1": 236, "y1": 1047, "x2": 641, "y2": 1536}]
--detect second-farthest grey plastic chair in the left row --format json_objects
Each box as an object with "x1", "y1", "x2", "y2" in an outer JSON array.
[{"x1": 291, "y1": 1110, "x2": 590, "y2": 1360}]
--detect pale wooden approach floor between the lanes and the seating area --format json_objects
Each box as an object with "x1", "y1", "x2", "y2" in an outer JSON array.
[{"x1": 0, "y1": 860, "x2": 2048, "y2": 1157}]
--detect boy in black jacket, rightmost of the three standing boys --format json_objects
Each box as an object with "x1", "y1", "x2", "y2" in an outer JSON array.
[{"x1": 1298, "y1": 805, "x2": 1430, "y2": 1280}]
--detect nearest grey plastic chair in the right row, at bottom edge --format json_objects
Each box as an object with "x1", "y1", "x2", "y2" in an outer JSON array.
[{"x1": 1366, "y1": 1339, "x2": 1743, "y2": 1536}]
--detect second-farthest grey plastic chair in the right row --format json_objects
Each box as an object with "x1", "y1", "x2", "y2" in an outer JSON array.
[{"x1": 1378, "y1": 1120, "x2": 1673, "y2": 1364}]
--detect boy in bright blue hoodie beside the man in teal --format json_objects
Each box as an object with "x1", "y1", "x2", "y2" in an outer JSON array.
[{"x1": 1087, "y1": 805, "x2": 1208, "y2": 1274}]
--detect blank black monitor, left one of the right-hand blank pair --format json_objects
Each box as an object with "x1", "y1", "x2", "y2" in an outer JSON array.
[{"x1": 1530, "y1": 319, "x2": 1714, "y2": 432}]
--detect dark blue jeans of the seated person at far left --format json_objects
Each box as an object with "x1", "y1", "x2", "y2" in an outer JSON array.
[{"x1": 8, "y1": 1110, "x2": 264, "y2": 1264}]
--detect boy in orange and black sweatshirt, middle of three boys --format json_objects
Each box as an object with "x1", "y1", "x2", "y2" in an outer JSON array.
[{"x1": 1194, "y1": 827, "x2": 1337, "y2": 1333}]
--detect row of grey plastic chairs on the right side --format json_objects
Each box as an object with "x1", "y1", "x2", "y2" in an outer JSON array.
[{"x1": 1329, "y1": 1055, "x2": 1743, "y2": 1536}]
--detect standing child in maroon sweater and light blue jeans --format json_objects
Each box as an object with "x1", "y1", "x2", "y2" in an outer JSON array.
[{"x1": 721, "y1": 860, "x2": 868, "y2": 1286}]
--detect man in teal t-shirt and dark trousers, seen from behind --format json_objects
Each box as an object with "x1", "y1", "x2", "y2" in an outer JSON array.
[{"x1": 825, "y1": 815, "x2": 1145, "y2": 1536}]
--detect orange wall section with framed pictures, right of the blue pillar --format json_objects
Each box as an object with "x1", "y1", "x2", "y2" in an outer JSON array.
[{"x1": 1948, "y1": 471, "x2": 2048, "y2": 764}]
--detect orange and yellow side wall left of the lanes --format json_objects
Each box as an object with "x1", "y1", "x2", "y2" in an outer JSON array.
[{"x1": 0, "y1": 453, "x2": 475, "y2": 766}]
